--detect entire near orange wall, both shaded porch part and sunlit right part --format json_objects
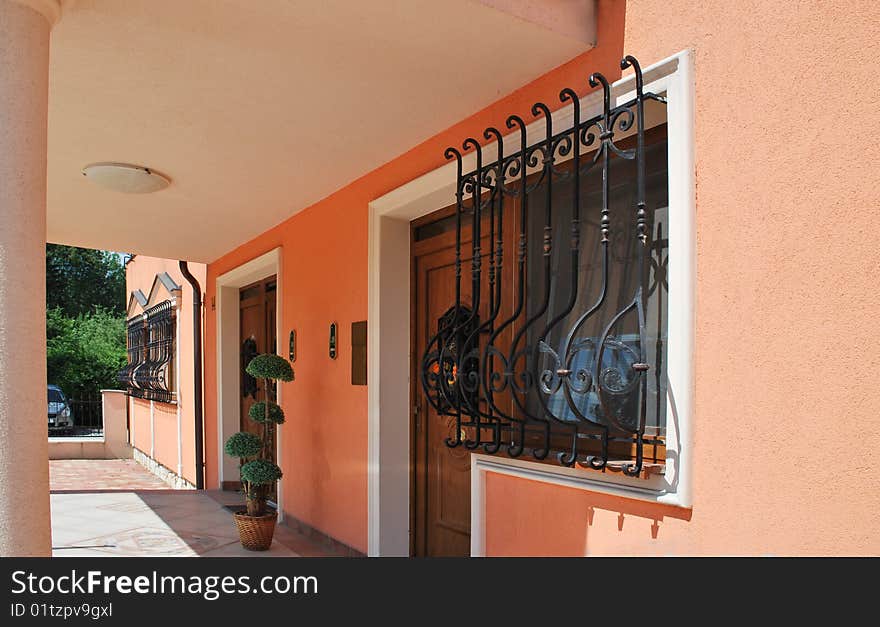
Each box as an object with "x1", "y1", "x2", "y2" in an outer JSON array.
[{"x1": 205, "y1": 0, "x2": 880, "y2": 555}]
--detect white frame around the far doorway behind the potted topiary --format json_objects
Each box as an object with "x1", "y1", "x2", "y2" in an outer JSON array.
[{"x1": 216, "y1": 246, "x2": 284, "y2": 521}]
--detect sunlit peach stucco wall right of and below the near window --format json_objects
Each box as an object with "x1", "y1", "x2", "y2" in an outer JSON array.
[{"x1": 486, "y1": 0, "x2": 880, "y2": 555}]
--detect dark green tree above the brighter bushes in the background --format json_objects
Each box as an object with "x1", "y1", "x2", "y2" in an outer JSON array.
[{"x1": 46, "y1": 244, "x2": 126, "y2": 318}]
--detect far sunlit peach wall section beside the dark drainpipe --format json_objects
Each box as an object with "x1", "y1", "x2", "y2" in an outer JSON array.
[{"x1": 126, "y1": 255, "x2": 206, "y2": 483}]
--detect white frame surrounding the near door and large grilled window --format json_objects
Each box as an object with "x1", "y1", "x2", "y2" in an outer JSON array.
[{"x1": 367, "y1": 50, "x2": 696, "y2": 555}]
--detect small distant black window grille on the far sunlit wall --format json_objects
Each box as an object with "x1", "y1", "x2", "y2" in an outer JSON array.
[{"x1": 119, "y1": 300, "x2": 176, "y2": 403}]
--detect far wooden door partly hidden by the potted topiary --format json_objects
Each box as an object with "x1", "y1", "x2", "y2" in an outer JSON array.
[{"x1": 239, "y1": 276, "x2": 277, "y2": 498}]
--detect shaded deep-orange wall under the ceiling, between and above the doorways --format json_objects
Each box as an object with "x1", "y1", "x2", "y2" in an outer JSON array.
[{"x1": 205, "y1": 1, "x2": 623, "y2": 552}]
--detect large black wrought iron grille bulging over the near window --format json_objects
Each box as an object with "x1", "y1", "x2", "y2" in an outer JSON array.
[{"x1": 419, "y1": 56, "x2": 666, "y2": 477}]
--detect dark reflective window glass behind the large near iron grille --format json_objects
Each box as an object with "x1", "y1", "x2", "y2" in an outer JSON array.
[{"x1": 527, "y1": 125, "x2": 668, "y2": 434}]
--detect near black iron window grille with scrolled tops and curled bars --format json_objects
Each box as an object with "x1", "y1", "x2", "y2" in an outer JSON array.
[{"x1": 420, "y1": 56, "x2": 665, "y2": 476}]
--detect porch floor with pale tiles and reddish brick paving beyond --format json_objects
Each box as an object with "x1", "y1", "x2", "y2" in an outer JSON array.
[{"x1": 49, "y1": 459, "x2": 344, "y2": 557}]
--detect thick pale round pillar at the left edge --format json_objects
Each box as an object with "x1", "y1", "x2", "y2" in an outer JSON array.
[{"x1": 0, "y1": 0, "x2": 60, "y2": 556}]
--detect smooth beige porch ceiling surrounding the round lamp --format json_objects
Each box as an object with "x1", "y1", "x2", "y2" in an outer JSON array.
[{"x1": 48, "y1": 0, "x2": 594, "y2": 262}]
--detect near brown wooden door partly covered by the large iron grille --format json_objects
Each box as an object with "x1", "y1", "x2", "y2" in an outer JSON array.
[{"x1": 411, "y1": 202, "x2": 517, "y2": 557}]
